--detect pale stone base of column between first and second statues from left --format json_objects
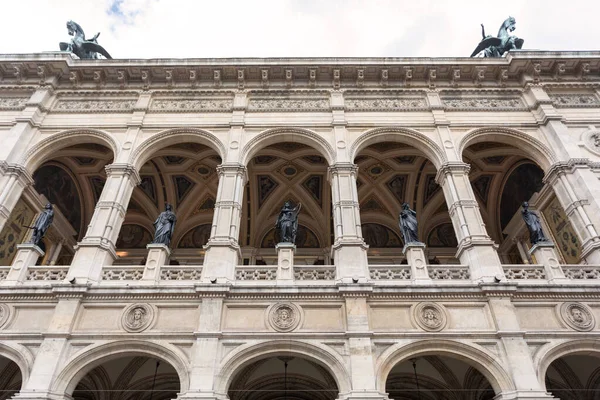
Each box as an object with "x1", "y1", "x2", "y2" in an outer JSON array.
[{"x1": 67, "y1": 239, "x2": 117, "y2": 283}]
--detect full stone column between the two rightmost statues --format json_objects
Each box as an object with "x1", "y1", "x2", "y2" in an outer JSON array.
[{"x1": 436, "y1": 161, "x2": 504, "y2": 282}]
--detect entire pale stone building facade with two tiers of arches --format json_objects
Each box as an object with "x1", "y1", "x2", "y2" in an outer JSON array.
[{"x1": 0, "y1": 51, "x2": 600, "y2": 400}]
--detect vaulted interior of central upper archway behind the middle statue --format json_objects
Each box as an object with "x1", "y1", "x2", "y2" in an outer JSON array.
[{"x1": 240, "y1": 142, "x2": 333, "y2": 265}]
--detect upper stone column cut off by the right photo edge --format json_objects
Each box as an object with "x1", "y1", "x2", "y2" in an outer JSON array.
[{"x1": 544, "y1": 159, "x2": 600, "y2": 264}]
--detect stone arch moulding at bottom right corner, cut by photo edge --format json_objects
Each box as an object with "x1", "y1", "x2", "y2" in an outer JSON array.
[{"x1": 533, "y1": 339, "x2": 600, "y2": 389}]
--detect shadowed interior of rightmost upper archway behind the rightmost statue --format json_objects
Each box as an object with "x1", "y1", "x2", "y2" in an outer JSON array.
[{"x1": 463, "y1": 142, "x2": 581, "y2": 264}]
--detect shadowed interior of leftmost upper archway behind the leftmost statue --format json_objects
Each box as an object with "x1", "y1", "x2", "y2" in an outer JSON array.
[{"x1": 0, "y1": 143, "x2": 113, "y2": 265}]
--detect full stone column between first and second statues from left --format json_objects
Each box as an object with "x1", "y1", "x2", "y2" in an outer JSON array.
[{"x1": 68, "y1": 163, "x2": 140, "y2": 283}]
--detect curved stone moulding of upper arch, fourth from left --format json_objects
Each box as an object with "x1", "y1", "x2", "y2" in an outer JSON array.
[{"x1": 350, "y1": 127, "x2": 447, "y2": 169}]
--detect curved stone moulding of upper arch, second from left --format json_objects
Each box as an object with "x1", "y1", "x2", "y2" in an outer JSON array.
[{"x1": 130, "y1": 128, "x2": 227, "y2": 171}]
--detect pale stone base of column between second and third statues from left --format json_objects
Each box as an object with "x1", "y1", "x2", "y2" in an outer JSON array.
[{"x1": 201, "y1": 240, "x2": 242, "y2": 282}]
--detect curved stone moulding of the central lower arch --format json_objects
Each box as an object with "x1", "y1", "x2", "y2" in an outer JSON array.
[{"x1": 214, "y1": 340, "x2": 352, "y2": 393}]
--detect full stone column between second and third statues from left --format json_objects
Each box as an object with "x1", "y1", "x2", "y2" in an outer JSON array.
[{"x1": 202, "y1": 164, "x2": 247, "y2": 281}]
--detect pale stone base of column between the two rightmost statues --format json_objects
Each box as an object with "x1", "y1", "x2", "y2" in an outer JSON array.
[{"x1": 456, "y1": 240, "x2": 504, "y2": 282}]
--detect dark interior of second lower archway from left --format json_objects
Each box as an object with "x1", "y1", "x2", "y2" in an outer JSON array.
[{"x1": 72, "y1": 356, "x2": 180, "y2": 400}]
